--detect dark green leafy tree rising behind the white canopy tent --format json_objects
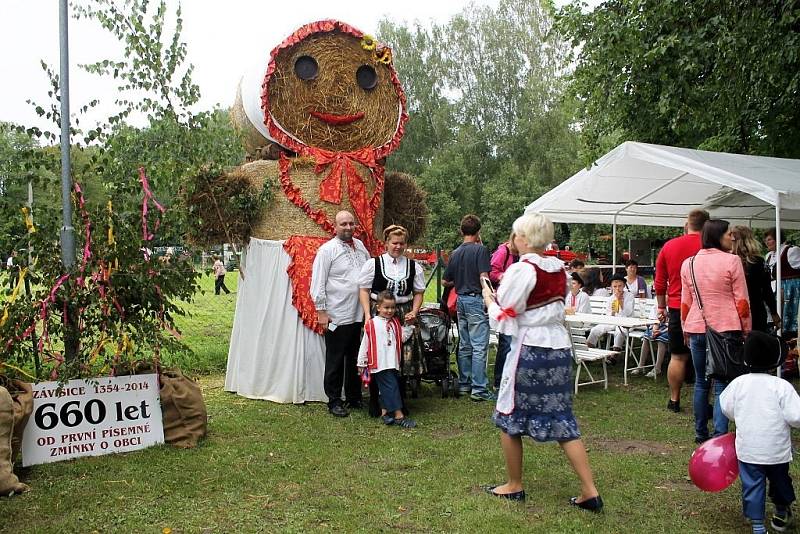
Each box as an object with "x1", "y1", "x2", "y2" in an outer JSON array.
[{"x1": 556, "y1": 0, "x2": 800, "y2": 164}]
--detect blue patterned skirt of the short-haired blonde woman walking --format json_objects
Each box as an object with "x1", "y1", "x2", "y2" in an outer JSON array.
[{"x1": 492, "y1": 345, "x2": 581, "y2": 441}]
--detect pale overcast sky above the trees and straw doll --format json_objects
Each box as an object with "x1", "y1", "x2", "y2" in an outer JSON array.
[{"x1": 0, "y1": 0, "x2": 497, "y2": 130}]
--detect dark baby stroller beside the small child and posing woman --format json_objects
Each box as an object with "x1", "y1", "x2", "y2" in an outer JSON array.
[{"x1": 411, "y1": 308, "x2": 458, "y2": 398}]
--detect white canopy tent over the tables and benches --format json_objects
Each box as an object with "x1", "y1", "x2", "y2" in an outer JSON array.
[{"x1": 525, "y1": 142, "x2": 800, "y2": 322}]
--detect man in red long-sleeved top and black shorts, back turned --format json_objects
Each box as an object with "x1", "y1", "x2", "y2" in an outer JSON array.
[{"x1": 655, "y1": 210, "x2": 709, "y2": 413}]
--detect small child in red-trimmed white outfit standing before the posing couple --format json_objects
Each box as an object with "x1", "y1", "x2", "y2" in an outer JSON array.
[{"x1": 356, "y1": 291, "x2": 417, "y2": 428}]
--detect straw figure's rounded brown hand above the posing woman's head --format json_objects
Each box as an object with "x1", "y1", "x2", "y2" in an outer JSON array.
[{"x1": 383, "y1": 172, "x2": 428, "y2": 243}]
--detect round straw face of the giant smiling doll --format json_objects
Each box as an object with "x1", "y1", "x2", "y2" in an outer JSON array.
[{"x1": 265, "y1": 30, "x2": 403, "y2": 152}]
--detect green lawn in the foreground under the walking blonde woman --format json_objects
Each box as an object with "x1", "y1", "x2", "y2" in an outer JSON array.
[{"x1": 0, "y1": 273, "x2": 796, "y2": 533}]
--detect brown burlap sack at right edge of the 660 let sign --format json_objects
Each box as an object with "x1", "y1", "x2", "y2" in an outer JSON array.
[{"x1": 161, "y1": 369, "x2": 208, "y2": 448}]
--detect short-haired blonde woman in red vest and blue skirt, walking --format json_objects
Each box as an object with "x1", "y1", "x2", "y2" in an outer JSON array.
[{"x1": 483, "y1": 213, "x2": 603, "y2": 512}]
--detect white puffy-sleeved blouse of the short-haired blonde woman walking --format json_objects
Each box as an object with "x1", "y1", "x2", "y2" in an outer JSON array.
[{"x1": 489, "y1": 253, "x2": 571, "y2": 349}]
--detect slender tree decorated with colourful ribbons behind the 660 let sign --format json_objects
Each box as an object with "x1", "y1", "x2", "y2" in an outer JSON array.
[{"x1": 0, "y1": 0, "x2": 241, "y2": 386}]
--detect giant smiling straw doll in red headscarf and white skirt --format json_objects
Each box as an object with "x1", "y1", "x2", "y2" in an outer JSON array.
[{"x1": 191, "y1": 20, "x2": 424, "y2": 403}]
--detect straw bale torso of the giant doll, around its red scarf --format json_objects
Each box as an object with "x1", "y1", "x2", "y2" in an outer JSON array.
[{"x1": 245, "y1": 158, "x2": 383, "y2": 240}]
